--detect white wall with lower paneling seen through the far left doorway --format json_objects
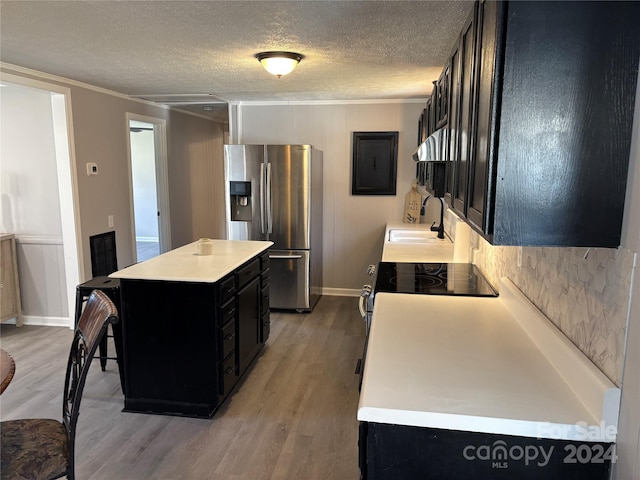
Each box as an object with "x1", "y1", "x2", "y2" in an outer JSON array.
[{"x1": 0, "y1": 84, "x2": 69, "y2": 324}]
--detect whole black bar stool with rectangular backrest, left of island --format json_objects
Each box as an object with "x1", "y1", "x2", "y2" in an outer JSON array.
[{"x1": 75, "y1": 232, "x2": 124, "y2": 393}]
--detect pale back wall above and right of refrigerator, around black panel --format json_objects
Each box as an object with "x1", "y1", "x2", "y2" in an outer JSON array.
[{"x1": 236, "y1": 100, "x2": 435, "y2": 293}]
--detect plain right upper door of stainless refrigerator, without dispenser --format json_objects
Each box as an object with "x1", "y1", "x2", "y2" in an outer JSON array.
[{"x1": 266, "y1": 145, "x2": 311, "y2": 250}]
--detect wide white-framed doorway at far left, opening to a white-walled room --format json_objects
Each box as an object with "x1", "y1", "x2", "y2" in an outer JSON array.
[{"x1": 0, "y1": 73, "x2": 82, "y2": 328}]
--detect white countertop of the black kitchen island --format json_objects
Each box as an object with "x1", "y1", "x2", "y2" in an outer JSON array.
[{"x1": 109, "y1": 240, "x2": 273, "y2": 283}]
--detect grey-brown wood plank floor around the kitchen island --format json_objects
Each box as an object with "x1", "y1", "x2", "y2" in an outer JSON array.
[{"x1": 0, "y1": 296, "x2": 364, "y2": 480}]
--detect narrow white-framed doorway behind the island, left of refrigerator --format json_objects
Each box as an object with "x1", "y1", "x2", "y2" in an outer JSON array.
[{"x1": 127, "y1": 114, "x2": 171, "y2": 262}]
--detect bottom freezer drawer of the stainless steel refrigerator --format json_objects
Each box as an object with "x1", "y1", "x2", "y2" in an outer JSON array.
[{"x1": 269, "y1": 250, "x2": 313, "y2": 311}]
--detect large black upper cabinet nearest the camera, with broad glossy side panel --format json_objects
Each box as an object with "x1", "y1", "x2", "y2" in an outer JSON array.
[{"x1": 440, "y1": 1, "x2": 640, "y2": 247}]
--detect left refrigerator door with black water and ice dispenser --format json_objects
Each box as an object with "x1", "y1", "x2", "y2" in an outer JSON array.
[{"x1": 224, "y1": 145, "x2": 267, "y2": 240}]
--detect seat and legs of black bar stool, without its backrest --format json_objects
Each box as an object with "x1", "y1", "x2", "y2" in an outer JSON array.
[{"x1": 75, "y1": 276, "x2": 124, "y2": 393}]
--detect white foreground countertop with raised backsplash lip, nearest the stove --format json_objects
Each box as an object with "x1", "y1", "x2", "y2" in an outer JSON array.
[{"x1": 358, "y1": 279, "x2": 619, "y2": 441}]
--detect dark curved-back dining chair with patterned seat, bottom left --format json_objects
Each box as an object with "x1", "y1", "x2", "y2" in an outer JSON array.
[{"x1": 0, "y1": 290, "x2": 118, "y2": 480}]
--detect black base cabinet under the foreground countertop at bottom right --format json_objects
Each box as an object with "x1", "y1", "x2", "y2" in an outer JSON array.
[{"x1": 359, "y1": 422, "x2": 615, "y2": 480}]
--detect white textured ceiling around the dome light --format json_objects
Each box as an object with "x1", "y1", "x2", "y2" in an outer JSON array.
[{"x1": 0, "y1": 0, "x2": 471, "y2": 119}]
